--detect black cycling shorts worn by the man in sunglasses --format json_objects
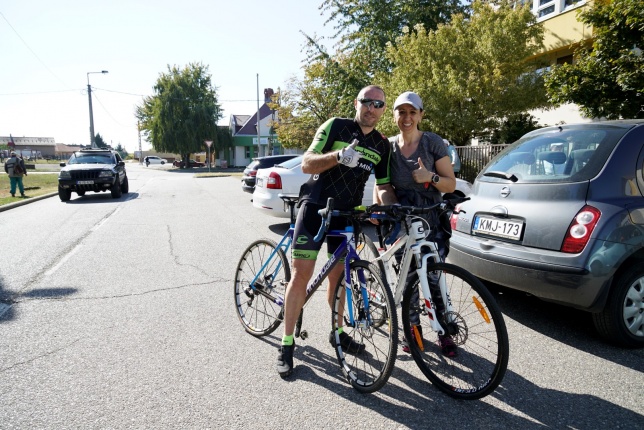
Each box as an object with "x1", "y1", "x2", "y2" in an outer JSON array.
[{"x1": 292, "y1": 202, "x2": 348, "y2": 260}]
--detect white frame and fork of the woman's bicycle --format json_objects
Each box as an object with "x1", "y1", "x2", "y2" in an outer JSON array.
[{"x1": 375, "y1": 216, "x2": 452, "y2": 335}]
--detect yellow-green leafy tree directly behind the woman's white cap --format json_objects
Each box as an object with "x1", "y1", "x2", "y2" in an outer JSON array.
[{"x1": 377, "y1": 1, "x2": 548, "y2": 145}]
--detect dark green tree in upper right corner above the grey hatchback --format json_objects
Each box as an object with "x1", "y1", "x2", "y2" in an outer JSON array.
[{"x1": 545, "y1": 0, "x2": 644, "y2": 119}]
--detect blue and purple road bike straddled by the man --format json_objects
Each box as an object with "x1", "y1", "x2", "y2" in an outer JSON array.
[{"x1": 234, "y1": 196, "x2": 398, "y2": 393}]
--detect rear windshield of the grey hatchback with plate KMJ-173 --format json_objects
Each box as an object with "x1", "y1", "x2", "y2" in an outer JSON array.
[{"x1": 477, "y1": 124, "x2": 628, "y2": 183}]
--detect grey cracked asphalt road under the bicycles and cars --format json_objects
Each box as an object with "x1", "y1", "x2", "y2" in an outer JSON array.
[{"x1": 0, "y1": 165, "x2": 644, "y2": 429}]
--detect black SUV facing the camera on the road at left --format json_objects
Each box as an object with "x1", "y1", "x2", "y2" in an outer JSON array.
[{"x1": 58, "y1": 149, "x2": 129, "y2": 202}]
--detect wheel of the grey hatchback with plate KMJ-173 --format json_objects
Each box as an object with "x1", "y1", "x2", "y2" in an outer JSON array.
[{"x1": 593, "y1": 263, "x2": 644, "y2": 348}]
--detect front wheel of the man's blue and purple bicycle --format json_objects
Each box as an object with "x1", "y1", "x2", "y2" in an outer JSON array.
[{"x1": 332, "y1": 261, "x2": 398, "y2": 393}]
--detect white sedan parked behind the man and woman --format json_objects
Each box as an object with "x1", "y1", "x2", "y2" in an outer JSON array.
[{"x1": 252, "y1": 156, "x2": 472, "y2": 218}]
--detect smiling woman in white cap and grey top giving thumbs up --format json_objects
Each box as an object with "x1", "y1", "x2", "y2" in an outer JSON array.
[{"x1": 374, "y1": 91, "x2": 458, "y2": 357}]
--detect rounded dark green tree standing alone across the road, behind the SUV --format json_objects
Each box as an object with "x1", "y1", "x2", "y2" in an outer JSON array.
[{"x1": 136, "y1": 63, "x2": 222, "y2": 165}]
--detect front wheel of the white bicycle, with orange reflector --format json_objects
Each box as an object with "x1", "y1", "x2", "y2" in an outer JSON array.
[{"x1": 402, "y1": 263, "x2": 509, "y2": 400}]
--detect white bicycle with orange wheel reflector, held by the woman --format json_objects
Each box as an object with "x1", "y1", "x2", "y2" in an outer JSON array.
[{"x1": 371, "y1": 195, "x2": 509, "y2": 400}]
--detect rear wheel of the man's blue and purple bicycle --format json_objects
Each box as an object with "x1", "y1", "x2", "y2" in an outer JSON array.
[{"x1": 235, "y1": 239, "x2": 291, "y2": 337}]
